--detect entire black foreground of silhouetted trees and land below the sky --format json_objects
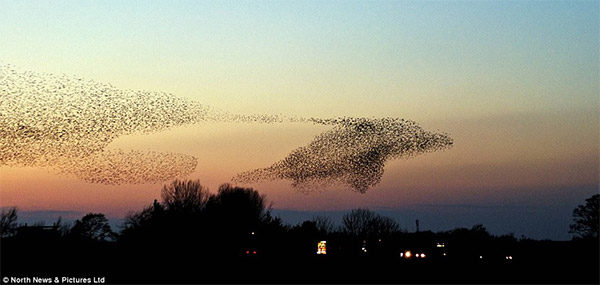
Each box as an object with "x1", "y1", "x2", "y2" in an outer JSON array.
[{"x1": 0, "y1": 180, "x2": 598, "y2": 283}]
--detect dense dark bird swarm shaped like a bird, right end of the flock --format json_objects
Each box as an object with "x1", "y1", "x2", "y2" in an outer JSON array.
[{"x1": 234, "y1": 118, "x2": 452, "y2": 193}]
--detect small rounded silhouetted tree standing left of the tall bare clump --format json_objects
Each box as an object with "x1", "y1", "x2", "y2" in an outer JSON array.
[{"x1": 70, "y1": 213, "x2": 115, "y2": 241}]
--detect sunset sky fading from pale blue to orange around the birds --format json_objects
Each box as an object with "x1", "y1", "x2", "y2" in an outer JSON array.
[{"x1": 0, "y1": 1, "x2": 600, "y2": 240}]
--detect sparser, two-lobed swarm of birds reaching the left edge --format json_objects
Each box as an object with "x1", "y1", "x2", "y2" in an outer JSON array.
[{"x1": 0, "y1": 66, "x2": 212, "y2": 184}]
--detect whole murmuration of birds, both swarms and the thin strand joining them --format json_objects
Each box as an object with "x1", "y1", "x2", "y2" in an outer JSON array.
[{"x1": 0, "y1": 65, "x2": 452, "y2": 193}]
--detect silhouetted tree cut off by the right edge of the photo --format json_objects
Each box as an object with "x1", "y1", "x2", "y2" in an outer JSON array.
[{"x1": 569, "y1": 194, "x2": 600, "y2": 238}]
